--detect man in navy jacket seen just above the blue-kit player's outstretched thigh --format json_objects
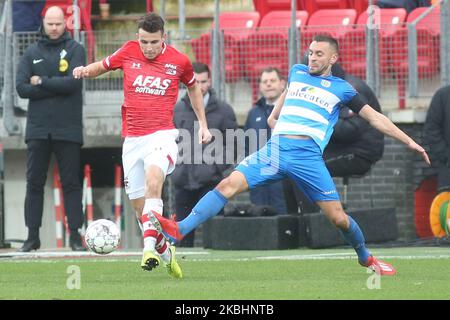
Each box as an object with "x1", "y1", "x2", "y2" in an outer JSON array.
[{"x1": 244, "y1": 67, "x2": 287, "y2": 214}]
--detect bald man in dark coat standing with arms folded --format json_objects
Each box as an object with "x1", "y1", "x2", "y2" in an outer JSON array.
[{"x1": 16, "y1": 7, "x2": 85, "y2": 252}]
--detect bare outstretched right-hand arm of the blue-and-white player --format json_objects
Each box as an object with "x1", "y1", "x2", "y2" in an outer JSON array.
[{"x1": 359, "y1": 104, "x2": 431, "y2": 165}]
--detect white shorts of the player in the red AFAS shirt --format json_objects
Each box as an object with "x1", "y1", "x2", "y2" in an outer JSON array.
[{"x1": 122, "y1": 129, "x2": 178, "y2": 200}]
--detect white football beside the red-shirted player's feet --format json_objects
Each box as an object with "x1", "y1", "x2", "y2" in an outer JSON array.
[{"x1": 84, "y1": 219, "x2": 120, "y2": 254}]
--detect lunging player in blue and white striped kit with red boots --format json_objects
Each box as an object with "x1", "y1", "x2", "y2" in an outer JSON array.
[{"x1": 149, "y1": 35, "x2": 430, "y2": 275}]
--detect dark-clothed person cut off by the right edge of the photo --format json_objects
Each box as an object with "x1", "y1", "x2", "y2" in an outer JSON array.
[{"x1": 423, "y1": 86, "x2": 450, "y2": 192}]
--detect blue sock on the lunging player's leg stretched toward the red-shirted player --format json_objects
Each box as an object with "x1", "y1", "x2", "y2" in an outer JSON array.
[{"x1": 178, "y1": 189, "x2": 228, "y2": 235}]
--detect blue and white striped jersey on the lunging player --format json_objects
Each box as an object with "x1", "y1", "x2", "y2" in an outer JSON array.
[{"x1": 272, "y1": 64, "x2": 357, "y2": 152}]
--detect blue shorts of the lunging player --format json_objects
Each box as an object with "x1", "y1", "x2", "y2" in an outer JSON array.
[{"x1": 236, "y1": 135, "x2": 339, "y2": 202}]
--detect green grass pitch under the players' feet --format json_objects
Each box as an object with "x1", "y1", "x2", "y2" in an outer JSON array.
[{"x1": 0, "y1": 247, "x2": 450, "y2": 300}]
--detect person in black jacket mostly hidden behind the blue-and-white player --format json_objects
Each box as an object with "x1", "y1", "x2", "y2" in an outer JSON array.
[{"x1": 284, "y1": 59, "x2": 384, "y2": 213}]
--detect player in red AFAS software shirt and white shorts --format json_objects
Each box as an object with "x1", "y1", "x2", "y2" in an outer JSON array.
[{"x1": 73, "y1": 13, "x2": 211, "y2": 278}]
